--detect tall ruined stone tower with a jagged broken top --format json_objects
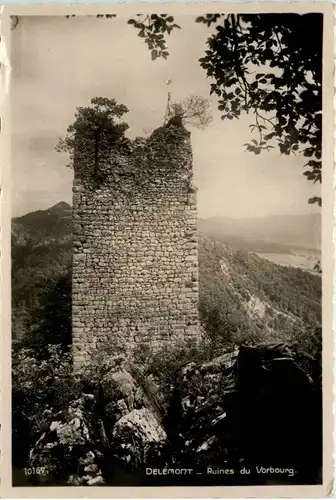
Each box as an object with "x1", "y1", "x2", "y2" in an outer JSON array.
[{"x1": 72, "y1": 121, "x2": 199, "y2": 367}]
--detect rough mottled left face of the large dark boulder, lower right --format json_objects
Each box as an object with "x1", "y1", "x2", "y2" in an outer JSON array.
[{"x1": 165, "y1": 349, "x2": 239, "y2": 466}]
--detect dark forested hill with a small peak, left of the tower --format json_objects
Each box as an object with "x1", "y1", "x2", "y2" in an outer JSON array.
[{"x1": 12, "y1": 202, "x2": 72, "y2": 348}]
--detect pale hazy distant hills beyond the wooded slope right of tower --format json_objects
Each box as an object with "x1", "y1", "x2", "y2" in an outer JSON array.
[{"x1": 198, "y1": 214, "x2": 321, "y2": 253}]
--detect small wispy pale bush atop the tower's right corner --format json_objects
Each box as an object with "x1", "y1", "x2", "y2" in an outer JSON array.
[{"x1": 166, "y1": 96, "x2": 213, "y2": 129}]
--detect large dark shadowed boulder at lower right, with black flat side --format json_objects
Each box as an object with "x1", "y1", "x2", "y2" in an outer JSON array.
[{"x1": 165, "y1": 342, "x2": 319, "y2": 476}]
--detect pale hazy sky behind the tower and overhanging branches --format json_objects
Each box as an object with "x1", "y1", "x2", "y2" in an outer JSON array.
[{"x1": 11, "y1": 16, "x2": 319, "y2": 217}]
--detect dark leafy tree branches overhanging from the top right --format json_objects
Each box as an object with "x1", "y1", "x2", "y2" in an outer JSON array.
[{"x1": 128, "y1": 13, "x2": 323, "y2": 205}]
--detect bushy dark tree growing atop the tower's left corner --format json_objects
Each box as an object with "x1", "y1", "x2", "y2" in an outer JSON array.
[{"x1": 56, "y1": 97, "x2": 128, "y2": 178}]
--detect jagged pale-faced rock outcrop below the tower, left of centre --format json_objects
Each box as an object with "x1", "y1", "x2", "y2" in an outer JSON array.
[{"x1": 29, "y1": 360, "x2": 166, "y2": 486}]
